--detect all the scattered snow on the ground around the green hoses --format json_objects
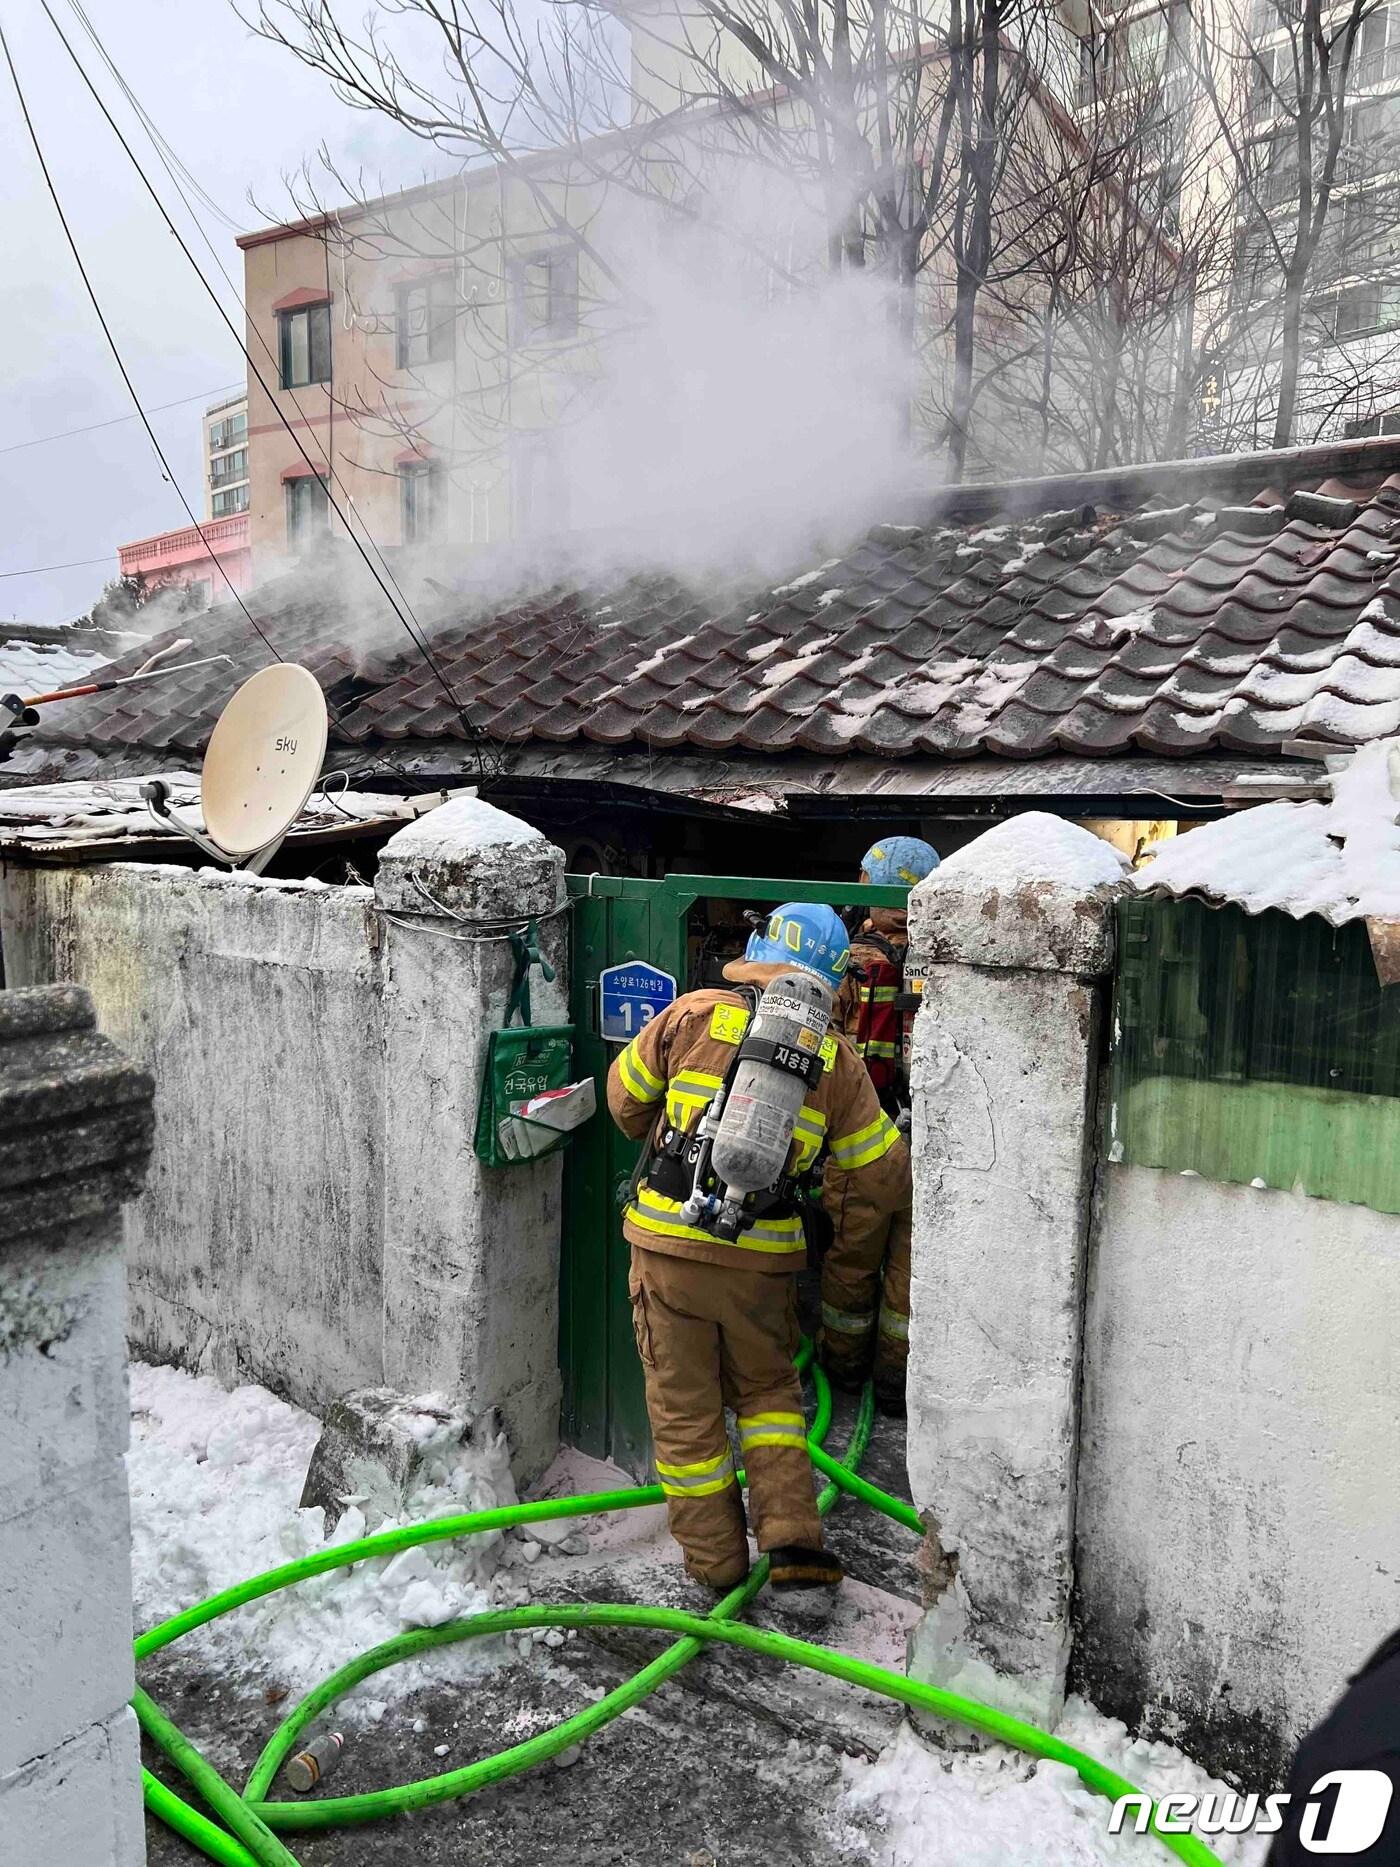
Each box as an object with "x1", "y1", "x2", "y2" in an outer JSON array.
[{"x1": 127, "y1": 1363, "x2": 1267, "y2": 1867}]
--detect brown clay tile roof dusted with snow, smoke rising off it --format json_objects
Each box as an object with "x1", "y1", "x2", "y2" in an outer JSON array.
[{"x1": 19, "y1": 439, "x2": 1400, "y2": 782}]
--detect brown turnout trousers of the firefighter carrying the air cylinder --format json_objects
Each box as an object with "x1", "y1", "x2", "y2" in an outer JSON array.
[{"x1": 627, "y1": 1245, "x2": 821, "y2": 1589}]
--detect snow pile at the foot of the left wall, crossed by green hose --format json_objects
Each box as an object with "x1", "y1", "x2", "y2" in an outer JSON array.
[{"x1": 127, "y1": 1363, "x2": 523, "y2": 1708}]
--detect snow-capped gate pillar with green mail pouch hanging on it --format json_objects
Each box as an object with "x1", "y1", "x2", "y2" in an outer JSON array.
[{"x1": 375, "y1": 797, "x2": 567, "y2": 1482}]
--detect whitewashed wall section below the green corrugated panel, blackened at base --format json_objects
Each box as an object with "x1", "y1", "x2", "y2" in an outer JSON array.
[{"x1": 1075, "y1": 1165, "x2": 1400, "y2": 1789}]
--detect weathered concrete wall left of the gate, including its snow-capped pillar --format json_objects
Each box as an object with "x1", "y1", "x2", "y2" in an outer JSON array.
[{"x1": 0, "y1": 799, "x2": 567, "y2": 1475}]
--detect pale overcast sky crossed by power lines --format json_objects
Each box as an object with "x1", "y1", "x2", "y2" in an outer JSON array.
[{"x1": 0, "y1": 0, "x2": 444, "y2": 622}]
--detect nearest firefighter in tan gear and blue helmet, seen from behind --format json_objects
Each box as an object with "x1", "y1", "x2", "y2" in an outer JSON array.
[{"x1": 609, "y1": 904, "x2": 909, "y2": 1591}]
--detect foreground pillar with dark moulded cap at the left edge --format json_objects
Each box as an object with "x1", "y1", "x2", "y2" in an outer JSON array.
[{"x1": 0, "y1": 986, "x2": 153, "y2": 1867}]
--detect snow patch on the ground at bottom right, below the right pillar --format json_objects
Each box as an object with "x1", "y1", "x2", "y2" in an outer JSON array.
[{"x1": 842, "y1": 1699, "x2": 1269, "y2": 1867}]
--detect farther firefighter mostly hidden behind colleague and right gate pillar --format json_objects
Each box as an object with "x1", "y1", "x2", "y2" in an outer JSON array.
[{"x1": 821, "y1": 836, "x2": 939, "y2": 1417}]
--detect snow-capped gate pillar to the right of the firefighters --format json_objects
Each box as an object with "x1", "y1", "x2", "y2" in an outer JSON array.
[{"x1": 909, "y1": 812, "x2": 1127, "y2": 1721}]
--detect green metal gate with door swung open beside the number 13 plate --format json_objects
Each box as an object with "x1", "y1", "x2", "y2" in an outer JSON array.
[{"x1": 560, "y1": 876, "x2": 907, "y2": 1477}]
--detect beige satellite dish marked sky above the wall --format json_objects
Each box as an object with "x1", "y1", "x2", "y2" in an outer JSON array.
[{"x1": 142, "y1": 661, "x2": 329, "y2": 874}]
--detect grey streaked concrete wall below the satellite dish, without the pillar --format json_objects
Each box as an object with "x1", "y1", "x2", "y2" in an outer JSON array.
[{"x1": 4, "y1": 863, "x2": 385, "y2": 1408}]
